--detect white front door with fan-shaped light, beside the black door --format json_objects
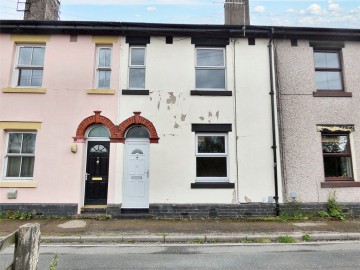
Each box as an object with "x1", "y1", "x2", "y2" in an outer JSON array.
[{"x1": 122, "y1": 139, "x2": 150, "y2": 208}]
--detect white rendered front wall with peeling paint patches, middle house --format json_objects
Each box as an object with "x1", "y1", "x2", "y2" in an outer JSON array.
[{"x1": 116, "y1": 37, "x2": 280, "y2": 203}]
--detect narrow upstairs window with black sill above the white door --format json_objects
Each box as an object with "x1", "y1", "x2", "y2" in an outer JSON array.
[{"x1": 129, "y1": 47, "x2": 146, "y2": 89}]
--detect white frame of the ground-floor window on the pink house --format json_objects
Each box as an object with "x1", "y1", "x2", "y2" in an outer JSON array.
[{"x1": 3, "y1": 130, "x2": 37, "y2": 180}]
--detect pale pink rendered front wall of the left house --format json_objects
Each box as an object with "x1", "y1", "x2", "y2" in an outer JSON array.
[{"x1": 0, "y1": 35, "x2": 120, "y2": 211}]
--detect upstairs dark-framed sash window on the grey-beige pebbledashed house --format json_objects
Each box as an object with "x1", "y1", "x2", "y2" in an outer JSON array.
[{"x1": 314, "y1": 50, "x2": 344, "y2": 91}]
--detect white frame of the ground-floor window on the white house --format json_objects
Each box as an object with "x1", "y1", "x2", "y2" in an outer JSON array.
[{"x1": 195, "y1": 132, "x2": 229, "y2": 182}]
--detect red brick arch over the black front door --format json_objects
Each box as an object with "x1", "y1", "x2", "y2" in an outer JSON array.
[{"x1": 74, "y1": 111, "x2": 118, "y2": 142}]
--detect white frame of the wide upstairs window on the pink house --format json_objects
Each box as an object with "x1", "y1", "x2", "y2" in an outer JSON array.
[{"x1": 13, "y1": 44, "x2": 46, "y2": 88}]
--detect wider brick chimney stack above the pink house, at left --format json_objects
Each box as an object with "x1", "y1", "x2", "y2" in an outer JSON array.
[{"x1": 24, "y1": 0, "x2": 60, "y2": 21}]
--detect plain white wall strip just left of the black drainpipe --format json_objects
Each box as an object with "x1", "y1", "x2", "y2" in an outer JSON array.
[{"x1": 236, "y1": 39, "x2": 282, "y2": 202}]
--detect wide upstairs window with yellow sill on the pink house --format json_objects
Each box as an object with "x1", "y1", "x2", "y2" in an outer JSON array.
[{"x1": 15, "y1": 45, "x2": 45, "y2": 87}]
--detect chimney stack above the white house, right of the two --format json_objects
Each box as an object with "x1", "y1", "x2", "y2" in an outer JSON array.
[{"x1": 224, "y1": 0, "x2": 250, "y2": 25}]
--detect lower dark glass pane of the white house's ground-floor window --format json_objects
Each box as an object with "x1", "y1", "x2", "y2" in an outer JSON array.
[{"x1": 196, "y1": 157, "x2": 227, "y2": 177}]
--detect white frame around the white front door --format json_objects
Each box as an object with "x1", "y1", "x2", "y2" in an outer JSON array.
[{"x1": 121, "y1": 138, "x2": 150, "y2": 209}]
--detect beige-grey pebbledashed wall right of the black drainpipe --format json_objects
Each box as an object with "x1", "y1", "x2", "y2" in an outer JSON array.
[{"x1": 276, "y1": 40, "x2": 360, "y2": 202}]
